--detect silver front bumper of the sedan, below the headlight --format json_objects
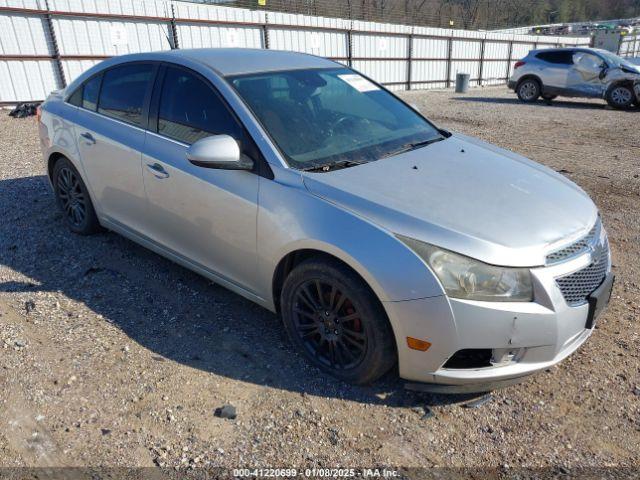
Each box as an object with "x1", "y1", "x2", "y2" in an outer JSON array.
[{"x1": 385, "y1": 251, "x2": 612, "y2": 393}]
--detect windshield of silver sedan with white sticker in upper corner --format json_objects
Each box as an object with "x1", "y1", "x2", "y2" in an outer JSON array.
[{"x1": 228, "y1": 68, "x2": 443, "y2": 169}]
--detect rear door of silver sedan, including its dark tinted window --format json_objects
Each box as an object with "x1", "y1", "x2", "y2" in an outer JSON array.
[{"x1": 76, "y1": 62, "x2": 158, "y2": 231}]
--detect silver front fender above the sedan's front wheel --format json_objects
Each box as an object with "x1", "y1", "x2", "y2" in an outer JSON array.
[{"x1": 256, "y1": 169, "x2": 444, "y2": 309}]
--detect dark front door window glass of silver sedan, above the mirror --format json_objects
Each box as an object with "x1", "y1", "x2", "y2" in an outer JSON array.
[{"x1": 158, "y1": 67, "x2": 243, "y2": 144}]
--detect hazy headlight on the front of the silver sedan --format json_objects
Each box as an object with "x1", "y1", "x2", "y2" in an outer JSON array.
[{"x1": 397, "y1": 235, "x2": 533, "y2": 302}]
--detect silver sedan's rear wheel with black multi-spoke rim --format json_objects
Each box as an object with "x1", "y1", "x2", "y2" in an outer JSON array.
[{"x1": 52, "y1": 158, "x2": 101, "y2": 235}]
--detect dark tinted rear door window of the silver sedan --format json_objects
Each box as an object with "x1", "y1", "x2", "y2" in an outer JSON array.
[{"x1": 97, "y1": 63, "x2": 154, "y2": 126}]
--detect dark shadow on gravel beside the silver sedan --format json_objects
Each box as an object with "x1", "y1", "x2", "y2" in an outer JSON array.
[{"x1": 0, "y1": 176, "x2": 478, "y2": 406}]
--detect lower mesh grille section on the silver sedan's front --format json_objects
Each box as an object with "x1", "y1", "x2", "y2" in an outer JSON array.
[{"x1": 556, "y1": 240, "x2": 609, "y2": 307}]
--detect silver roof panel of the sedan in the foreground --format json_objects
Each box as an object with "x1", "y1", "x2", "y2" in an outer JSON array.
[{"x1": 156, "y1": 48, "x2": 339, "y2": 76}]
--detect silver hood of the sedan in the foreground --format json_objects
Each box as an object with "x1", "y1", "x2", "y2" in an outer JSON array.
[{"x1": 303, "y1": 134, "x2": 598, "y2": 266}]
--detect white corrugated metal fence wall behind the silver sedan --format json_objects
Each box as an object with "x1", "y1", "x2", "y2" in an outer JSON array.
[{"x1": 0, "y1": 0, "x2": 592, "y2": 104}]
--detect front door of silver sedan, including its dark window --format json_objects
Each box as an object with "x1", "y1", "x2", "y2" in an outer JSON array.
[{"x1": 142, "y1": 67, "x2": 259, "y2": 290}]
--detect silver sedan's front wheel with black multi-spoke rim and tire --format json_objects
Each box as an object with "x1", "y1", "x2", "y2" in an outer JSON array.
[{"x1": 280, "y1": 258, "x2": 397, "y2": 385}]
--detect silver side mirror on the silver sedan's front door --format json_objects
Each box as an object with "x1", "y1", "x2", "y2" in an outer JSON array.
[{"x1": 187, "y1": 135, "x2": 253, "y2": 170}]
